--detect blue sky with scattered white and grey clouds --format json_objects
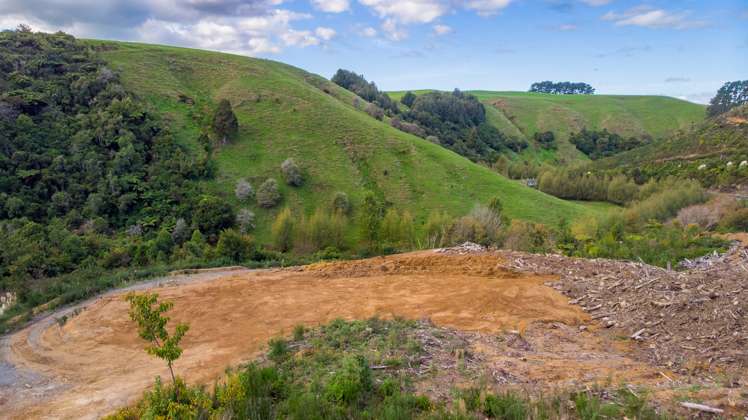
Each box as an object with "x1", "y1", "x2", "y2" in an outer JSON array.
[{"x1": 0, "y1": 0, "x2": 748, "y2": 103}]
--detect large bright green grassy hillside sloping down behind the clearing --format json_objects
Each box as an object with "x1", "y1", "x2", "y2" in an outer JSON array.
[{"x1": 91, "y1": 41, "x2": 599, "y2": 240}]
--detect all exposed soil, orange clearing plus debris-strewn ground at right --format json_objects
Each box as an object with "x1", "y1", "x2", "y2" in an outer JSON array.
[{"x1": 0, "y1": 247, "x2": 748, "y2": 418}]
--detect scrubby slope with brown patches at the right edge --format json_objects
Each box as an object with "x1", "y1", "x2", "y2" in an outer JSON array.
[{"x1": 596, "y1": 105, "x2": 748, "y2": 186}]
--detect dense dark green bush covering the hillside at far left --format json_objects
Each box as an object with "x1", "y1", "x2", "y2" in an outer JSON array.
[{"x1": 0, "y1": 31, "x2": 205, "y2": 227}]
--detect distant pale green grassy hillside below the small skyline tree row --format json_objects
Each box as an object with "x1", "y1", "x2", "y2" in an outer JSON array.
[{"x1": 390, "y1": 91, "x2": 705, "y2": 160}]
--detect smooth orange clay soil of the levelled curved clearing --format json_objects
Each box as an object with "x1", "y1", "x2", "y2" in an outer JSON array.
[{"x1": 0, "y1": 251, "x2": 668, "y2": 418}]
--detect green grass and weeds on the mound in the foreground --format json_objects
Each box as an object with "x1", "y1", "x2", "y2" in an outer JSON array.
[{"x1": 109, "y1": 318, "x2": 666, "y2": 420}]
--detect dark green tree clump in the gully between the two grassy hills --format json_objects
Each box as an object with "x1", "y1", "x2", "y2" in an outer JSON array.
[{"x1": 403, "y1": 89, "x2": 527, "y2": 162}]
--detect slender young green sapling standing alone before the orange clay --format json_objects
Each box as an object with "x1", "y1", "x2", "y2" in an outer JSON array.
[{"x1": 125, "y1": 293, "x2": 190, "y2": 392}]
